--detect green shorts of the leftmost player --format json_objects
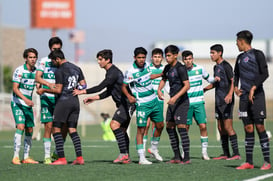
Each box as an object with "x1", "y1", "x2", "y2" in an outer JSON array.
[{"x1": 11, "y1": 101, "x2": 34, "y2": 128}]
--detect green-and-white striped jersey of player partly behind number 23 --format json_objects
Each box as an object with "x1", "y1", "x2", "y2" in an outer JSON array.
[{"x1": 37, "y1": 57, "x2": 57, "y2": 99}]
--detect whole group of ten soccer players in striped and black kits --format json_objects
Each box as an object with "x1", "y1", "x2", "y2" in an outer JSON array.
[{"x1": 11, "y1": 30, "x2": 271, "y2": 170}]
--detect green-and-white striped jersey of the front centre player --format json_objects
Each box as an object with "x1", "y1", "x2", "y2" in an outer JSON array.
[{"x1": 123, "y1": 63, "x2": 157, "y2": 106}]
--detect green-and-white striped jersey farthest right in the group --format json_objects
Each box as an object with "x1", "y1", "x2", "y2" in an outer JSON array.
[{"x1": 187, "y1": 64, "x2": 214, "y2": 105}]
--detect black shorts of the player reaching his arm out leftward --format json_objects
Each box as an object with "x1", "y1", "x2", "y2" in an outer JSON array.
[{"x1": 112, "y1": 103, "x2": 136, "y2": 129}]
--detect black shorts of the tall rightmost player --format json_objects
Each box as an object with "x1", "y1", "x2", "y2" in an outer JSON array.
[{"x1": 239, "y1": 92, "x2": 266, "y2": 125}]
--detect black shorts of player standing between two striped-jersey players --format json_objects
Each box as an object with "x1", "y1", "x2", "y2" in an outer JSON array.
[{"x1": 166, "y1": 99, "x2": 190, "y2": 125}]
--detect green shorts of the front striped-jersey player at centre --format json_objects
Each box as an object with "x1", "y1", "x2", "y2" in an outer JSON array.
[{"x1": 136, "y1": 99, "x2": 164, "y2": 127}]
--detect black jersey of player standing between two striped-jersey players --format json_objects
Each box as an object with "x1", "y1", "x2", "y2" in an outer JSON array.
[{"x1": 162, "y1": 62, "x2": 189, "y2": 100}]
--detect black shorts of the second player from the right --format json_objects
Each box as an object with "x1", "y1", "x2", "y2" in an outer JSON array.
[{"x1": 215, "y1": 102, "x2": 234, "y2": 120}]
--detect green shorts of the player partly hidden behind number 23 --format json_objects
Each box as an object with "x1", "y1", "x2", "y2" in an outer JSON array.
[{"x1": 41, "y1": 96, "x2": 55, "y2": 123}]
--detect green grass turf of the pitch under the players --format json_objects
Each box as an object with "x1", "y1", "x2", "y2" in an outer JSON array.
[{"x1": 0, "y1": 121, "x2": 273, "y2": 181}]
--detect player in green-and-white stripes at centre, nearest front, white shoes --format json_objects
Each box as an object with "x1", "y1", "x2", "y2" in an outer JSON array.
[{"x1": 122, "y1": 47, "x2": 164, "y2": 165}]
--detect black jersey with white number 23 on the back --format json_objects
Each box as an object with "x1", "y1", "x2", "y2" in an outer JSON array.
[{"x1": 55, "y1": 62, "x2": 84, "y2": 100}]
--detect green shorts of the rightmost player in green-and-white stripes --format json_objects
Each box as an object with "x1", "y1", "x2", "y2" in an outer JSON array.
[{"x1": 187, "y1": 103, "x2": 207, "y2": 125}]
